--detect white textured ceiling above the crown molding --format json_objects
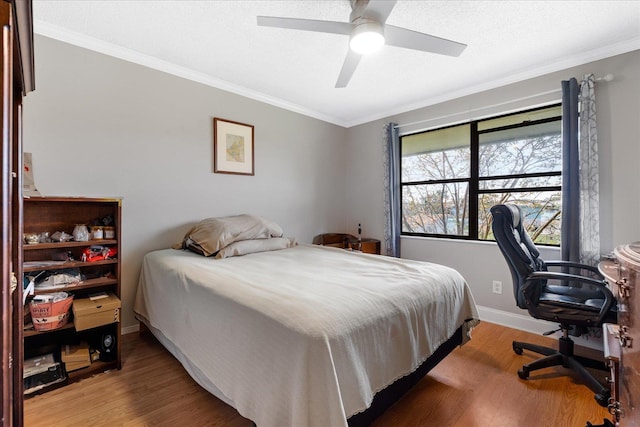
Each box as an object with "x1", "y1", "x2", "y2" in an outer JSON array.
[{"x1": 33, "y1": 0, "x2": 640, "y2": 127}]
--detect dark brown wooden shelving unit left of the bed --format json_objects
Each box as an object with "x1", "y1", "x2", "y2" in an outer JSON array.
[{"x1": 22, "y1": 197, "x2": 121, "y2": 393}]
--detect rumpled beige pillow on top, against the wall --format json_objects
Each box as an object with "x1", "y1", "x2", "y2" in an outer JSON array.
[{"x1": 182, "y1": 214, "x2": 283, "y2": 256}]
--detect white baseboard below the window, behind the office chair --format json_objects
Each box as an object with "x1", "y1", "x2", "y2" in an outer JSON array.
[{"x1": 477, "y1": 305, "x2": 604, "y2": 350}]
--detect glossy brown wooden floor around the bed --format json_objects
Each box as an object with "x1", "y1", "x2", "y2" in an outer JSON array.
[{"x1": 24, "y1": 322, "x2": 608, "y2": 427}]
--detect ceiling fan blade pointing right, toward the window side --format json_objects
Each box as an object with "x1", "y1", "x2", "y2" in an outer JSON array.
[{"x1": 384, "y1": 25, "x2": 467, "y2": 56}]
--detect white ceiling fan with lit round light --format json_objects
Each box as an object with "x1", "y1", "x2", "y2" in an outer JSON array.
[{"x1": 258, "y1": 0, "x2": 467, "y2": 88}]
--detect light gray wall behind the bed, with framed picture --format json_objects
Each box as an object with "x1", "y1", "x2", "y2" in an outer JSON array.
[{"x1": 24, "y1": 36, "x2": 347, "y2": 328}]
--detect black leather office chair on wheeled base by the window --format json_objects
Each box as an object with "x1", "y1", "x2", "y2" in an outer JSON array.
[{"x1": 491, "y1": 205, "x2": 617, "y2": 407}]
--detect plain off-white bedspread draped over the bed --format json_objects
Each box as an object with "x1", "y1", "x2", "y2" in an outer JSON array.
[{"x1": 134, "y1": 245, "x2": 478, "y2": 427}]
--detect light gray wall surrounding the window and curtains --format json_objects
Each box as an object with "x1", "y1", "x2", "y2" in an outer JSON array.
[{"x1": 346, "y1": 51, "x2": 640, "y2": 326}]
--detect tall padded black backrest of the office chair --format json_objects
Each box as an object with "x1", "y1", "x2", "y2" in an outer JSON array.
[{"x1": 491, "y1": 205, "x2": 547, "y2": 309}]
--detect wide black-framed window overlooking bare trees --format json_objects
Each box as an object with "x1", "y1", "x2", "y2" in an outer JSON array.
[{"x1": 400, "y1": 105, "x2": 562, "y2": 245}]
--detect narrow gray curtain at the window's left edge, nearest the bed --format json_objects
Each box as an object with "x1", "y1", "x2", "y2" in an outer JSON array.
[{"x1": 383, "y1": 123, "x2": 401, "y2": 258}]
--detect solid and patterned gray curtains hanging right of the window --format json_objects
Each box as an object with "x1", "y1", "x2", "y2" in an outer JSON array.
[{"x1": 560, "y1": 75, "x2": 600, "y2": 265}]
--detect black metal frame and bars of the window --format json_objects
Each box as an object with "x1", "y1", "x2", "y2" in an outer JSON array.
[{"x1": 398, "y1": 102, "x2": 562, "y2": 247}]
